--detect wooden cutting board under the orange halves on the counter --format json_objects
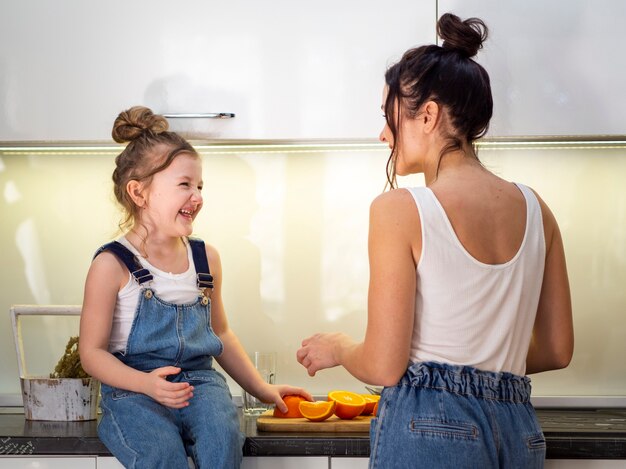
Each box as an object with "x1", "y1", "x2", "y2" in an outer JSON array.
[{"x1": 256, "y1": 410, "x2": 373, "y2": 433}]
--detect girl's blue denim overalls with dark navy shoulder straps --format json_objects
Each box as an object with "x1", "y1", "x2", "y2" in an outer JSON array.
[{"x1": 96, "y1": 239, "x2": 244, "y2": 469}]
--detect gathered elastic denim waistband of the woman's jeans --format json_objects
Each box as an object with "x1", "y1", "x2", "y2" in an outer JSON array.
[{"x1": 398, "y1": 362, "x2": 531, "y2": 403}]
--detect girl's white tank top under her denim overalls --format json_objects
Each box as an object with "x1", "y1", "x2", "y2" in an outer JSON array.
[{"x1": 109, "y1": 237, "x2": 199, "y2": 353}]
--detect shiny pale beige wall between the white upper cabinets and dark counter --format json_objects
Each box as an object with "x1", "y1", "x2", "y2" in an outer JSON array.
[{"x1": 0, "y1": 141, "x2": 626, "y2": 396}]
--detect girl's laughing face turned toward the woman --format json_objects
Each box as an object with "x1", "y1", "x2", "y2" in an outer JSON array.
[{"x1": 141, "y1": 153, "x2": 203, "y2": 236}]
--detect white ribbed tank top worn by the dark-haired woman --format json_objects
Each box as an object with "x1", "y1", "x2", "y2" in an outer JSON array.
[{"x1": 408, "y1": 184, "x2": 546, "y2": 375}]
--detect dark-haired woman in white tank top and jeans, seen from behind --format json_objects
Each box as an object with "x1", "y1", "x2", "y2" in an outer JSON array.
[{"x1": 297, "y1": 14, "x2": 574, "y2": 468}]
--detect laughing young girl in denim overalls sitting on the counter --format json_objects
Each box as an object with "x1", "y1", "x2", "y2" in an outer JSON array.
[{"x1": 80, "y1": 107, "x2": 312, "y2": 469}]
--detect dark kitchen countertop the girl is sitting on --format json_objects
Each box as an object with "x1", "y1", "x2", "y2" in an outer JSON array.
[{"x1": 0, "y1": 408, "x2": 626, "y2": 459}]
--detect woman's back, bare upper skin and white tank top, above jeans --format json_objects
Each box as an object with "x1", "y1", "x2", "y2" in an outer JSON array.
[{"x1": 410, "y1": 170, "x2": 545, "y2": 375}]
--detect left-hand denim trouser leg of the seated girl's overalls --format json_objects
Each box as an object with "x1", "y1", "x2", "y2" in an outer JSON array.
[{"x1": 98, "y1": 392, "x2": 188, "y2": 469}]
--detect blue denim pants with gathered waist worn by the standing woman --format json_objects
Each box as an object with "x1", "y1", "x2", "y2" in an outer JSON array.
[{"x1": 369, "y1": 362, "x2": 546, "y2": 469}]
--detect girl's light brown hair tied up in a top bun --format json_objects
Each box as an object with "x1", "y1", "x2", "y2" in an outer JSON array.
[{"x1": 111, "y1": 106, "x2": 198, "y2": 231}]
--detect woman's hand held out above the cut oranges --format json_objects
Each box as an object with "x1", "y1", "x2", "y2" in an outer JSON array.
[{"x1": 296, "y1": 332, "x2": 354, "y2": 376}]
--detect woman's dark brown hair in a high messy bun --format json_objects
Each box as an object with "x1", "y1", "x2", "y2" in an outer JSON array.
[{"x1": 384, "y1": 13, "x2": 493, "y2": 188}]
